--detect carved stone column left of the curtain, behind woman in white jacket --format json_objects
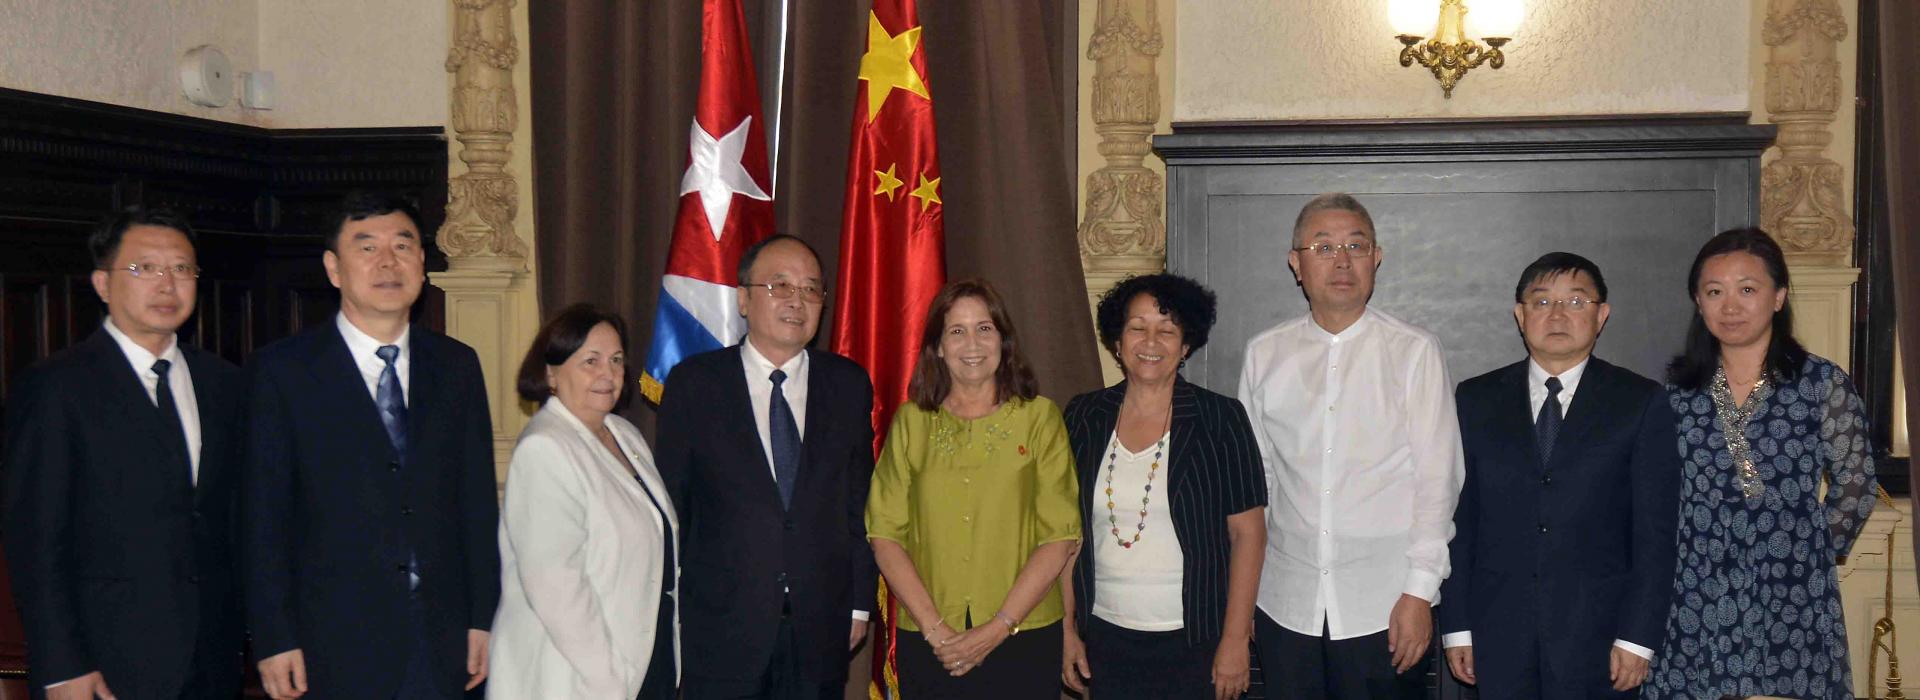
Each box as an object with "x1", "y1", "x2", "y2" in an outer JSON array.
[{"x1": 432, "y1": 0, "x2": 532, "y2": 476}]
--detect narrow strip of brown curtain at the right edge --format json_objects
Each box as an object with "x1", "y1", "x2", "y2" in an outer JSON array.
[{"x1": 1878, "y1": 0, "x2": 1920, "y2": 575}]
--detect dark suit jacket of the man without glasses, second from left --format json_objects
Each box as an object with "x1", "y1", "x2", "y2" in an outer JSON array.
[{"x1": 242, "y1": 318, "x2": 499, "y2": 698}]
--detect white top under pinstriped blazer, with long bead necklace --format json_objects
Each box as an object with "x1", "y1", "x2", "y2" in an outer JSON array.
[{"x1": 1087, "y1": 427, "x2": 1187, "y2": 633}]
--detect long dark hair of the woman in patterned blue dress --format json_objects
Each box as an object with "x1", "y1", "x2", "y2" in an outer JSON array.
[{"x1": 1667, "y1": 228, "x2": 1807, "y2": 391}]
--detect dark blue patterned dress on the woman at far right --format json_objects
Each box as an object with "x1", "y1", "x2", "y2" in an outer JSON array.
[{"x1": 1644, "y1": 355, "x2": 1876, "y2": 700}]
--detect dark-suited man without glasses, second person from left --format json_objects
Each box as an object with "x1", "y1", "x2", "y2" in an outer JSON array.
[{"x1": 240, "y1": 194, "x2": 499, "y2": 700}]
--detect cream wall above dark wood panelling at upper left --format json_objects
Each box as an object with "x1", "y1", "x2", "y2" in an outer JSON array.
[{"x1": 0, "y1": 0, "x2": 449, "y2": 128}]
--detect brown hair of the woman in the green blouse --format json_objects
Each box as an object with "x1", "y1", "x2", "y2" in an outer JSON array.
[{"x1": 906, "y1": 278, "x2": 1041, "y2": 410}]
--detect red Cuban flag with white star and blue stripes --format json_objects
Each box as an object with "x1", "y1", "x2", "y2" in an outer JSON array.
[{"x1": 639, "y1": 0, "x2": 774, "y2": 403}]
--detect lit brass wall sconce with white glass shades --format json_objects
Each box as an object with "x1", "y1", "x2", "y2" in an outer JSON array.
[{"x1": 1386, "y1": 0, "x2": 1523, "y2": 100}]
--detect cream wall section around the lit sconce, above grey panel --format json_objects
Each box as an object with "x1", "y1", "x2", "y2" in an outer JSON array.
[{"x1": 1173, "y1": 0, "x2": 1753, "y2": 121}]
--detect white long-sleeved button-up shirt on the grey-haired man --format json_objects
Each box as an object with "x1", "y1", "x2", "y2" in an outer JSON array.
[{"x1": 1240, "y1": 309, "x2": 1465, "y2": 639}]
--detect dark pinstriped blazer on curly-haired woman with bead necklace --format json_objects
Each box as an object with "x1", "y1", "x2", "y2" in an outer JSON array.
[{"x1": 1066, "y1": 378, "x2": 1267, "y2": 644}]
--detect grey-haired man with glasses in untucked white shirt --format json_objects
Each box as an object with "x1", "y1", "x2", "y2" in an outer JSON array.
[{"x1": 1240, "y1": 194, "x2": 1461, "y2": 698}]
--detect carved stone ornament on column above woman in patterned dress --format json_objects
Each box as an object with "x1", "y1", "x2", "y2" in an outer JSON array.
[{"x1": 1761, "y1": 0, "x2": 1855, "y2": 265}]
